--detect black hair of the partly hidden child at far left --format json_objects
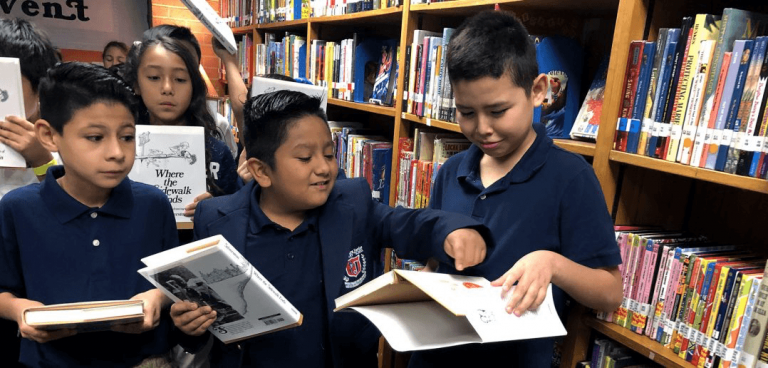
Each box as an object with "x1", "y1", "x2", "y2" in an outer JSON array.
[{"x1": 0, "y1": 18, "x2": 59, "y2": 92}]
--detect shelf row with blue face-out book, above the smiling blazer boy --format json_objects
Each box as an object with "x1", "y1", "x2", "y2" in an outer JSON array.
[{"x1": 309, "y1": 33, "x2": 398, "y2": 105}]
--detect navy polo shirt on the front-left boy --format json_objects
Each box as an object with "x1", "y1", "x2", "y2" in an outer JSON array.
[{"x1": 0, "y1": 166, "x2": 178, "y2": 367}]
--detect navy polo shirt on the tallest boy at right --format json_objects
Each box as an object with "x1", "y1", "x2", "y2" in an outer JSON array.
[{"x1": 411, "y1": 124, "x2": 621, "y2": 367}]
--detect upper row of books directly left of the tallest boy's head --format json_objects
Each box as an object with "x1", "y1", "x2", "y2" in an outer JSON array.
[{"x1": 403, "y1": 28, "x2": 456, "y2": 121}]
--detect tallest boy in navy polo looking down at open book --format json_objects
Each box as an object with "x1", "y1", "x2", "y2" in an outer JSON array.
[{"x1": 410, "y1": 11, "x2": 622, "y2": 367}]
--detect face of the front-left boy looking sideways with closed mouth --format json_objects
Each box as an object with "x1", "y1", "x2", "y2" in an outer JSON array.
[{"x1": 52, "y1": 102, "x2": 136, "y2": 190}]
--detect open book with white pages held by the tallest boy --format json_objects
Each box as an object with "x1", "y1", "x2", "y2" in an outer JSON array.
[{"x1": 335, "y1": 270, "x2": 566, "y2": 351}]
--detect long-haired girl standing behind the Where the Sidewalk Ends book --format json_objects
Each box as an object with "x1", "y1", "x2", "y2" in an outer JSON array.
[{"x1": 125, "y1": 28, "x2": 237, "y2": 216}]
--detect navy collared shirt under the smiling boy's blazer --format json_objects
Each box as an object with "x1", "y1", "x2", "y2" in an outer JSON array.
[{"x1": 238, "y1": 187, "x2": 330, "y2": 368}]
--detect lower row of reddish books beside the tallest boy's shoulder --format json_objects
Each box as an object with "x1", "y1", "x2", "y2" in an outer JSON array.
[{"x1": 395, "y1": 128, "x2": 471, "y2": 208}]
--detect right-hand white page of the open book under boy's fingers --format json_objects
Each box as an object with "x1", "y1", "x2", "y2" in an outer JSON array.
[{"x1": 466, "y1": 284, "x2": 566, "y2": 343}]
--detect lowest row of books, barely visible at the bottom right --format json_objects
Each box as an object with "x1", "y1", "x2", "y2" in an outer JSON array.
[{"x1": 588, "y1": 337, "x2": 661, "y2": 368}]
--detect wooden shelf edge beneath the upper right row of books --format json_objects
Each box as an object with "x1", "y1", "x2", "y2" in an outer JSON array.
[{"x1": 609, "y1": 151, "x2": 768, "y2": 194}]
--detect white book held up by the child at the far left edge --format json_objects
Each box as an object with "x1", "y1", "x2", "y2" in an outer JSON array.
[{"x1": 0, "y1": 57, "x2": 27, "y2": 168}]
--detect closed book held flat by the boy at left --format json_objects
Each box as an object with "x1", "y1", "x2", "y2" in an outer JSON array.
[{"x1": 23, "y1": 300, "x2": 144, "y2": 332}]
